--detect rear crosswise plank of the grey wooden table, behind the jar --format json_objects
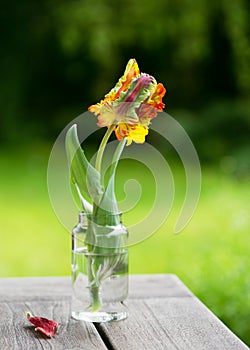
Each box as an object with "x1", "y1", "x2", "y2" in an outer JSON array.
[{"x1": 0, "y1": 274, "x2": 192, "y2": 300}]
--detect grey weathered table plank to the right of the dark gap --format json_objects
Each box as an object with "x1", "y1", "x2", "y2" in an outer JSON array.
[{"x1": 97, "y1": 276, "x2": 248, "y2": 350}]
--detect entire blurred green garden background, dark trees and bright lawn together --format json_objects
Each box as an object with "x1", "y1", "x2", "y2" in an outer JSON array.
[{"x1": 0, "y1": 0, "x2": 250, "y2": 344}]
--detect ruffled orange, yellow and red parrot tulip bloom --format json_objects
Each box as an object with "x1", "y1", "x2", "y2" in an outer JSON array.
[{"x1": 89, "y1": 59, "x2": 166, "y2": 145}]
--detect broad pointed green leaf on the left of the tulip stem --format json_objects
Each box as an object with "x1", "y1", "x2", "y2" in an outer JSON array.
[{"x1": 65, "y1": 124, "x2": 103, "y2": 208}]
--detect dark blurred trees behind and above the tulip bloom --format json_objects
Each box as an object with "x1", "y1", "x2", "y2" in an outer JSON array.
[{"x1": 0, "y1": 0, "x2": 250, "y2": 160}]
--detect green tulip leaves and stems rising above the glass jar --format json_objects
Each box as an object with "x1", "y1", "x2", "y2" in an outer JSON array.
[{"x1": 65, "y1": 124, "x2": 126, "y2": 226}]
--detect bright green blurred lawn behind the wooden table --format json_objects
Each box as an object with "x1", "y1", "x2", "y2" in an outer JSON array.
[{"x1": 0, "y1": 145, "x2": 250, "y2": 344}]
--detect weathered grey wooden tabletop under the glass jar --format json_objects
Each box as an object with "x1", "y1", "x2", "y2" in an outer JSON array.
[{"x1": 0, "y1": 275, "x2": 248, "y2": 350}]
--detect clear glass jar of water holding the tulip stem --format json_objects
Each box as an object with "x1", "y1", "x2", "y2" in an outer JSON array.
[{"x1": 72, "y1": 212, "x2": 128, "y2": 322}]
